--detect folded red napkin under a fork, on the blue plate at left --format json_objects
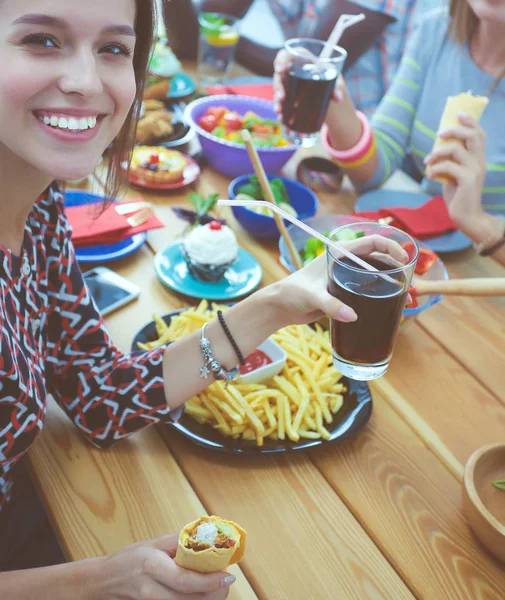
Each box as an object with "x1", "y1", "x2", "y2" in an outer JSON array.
[{"x1": 65, "y1": 200, "x2": 164, "y2": 248}]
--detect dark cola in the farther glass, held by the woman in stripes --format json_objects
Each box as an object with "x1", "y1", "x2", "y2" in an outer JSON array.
[{"x1": 282, "y1": 63, "x2": 338, "y2": 133}]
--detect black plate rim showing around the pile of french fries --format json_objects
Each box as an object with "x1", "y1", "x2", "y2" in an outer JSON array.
[{"x1": 132, "y1": 308, "x2": 372, "y2": 455}]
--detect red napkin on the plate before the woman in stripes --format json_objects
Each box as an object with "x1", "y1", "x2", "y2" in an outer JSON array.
[{"x1": 356, "y1": 196, "x2": 457, "y2": 240}]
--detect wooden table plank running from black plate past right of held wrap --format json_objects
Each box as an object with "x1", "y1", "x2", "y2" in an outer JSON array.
[{"x1": 161, "y1": 430, "x2": 413, "y2": 600}]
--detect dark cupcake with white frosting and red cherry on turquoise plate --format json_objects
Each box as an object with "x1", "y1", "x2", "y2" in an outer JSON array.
[{"x1": 181, "y1": 221, "x2": 238, "y2": 283}]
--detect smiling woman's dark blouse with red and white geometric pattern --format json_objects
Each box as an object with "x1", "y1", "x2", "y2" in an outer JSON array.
[{"x1": 0, "y1": 186, "x2": 170, "y2": 510}]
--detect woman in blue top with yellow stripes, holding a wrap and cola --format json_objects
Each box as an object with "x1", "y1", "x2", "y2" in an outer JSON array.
[{"x1": 276, "y1": 0, "x2": 505, "y2": 265}]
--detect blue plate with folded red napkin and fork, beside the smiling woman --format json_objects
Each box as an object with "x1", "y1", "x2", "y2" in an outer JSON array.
[{"x1": 64, "y1": 190, "x2": 163, "y2": 263}]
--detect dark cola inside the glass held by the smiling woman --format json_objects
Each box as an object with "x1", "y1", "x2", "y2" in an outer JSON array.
[{"x1": 328, "y1": 256, "x2": 409, "y2": 365}]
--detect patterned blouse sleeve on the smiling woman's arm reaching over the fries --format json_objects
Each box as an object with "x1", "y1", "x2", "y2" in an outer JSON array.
[{"x1": 46, "y1": 192, "x2": 170, "y2": 447}]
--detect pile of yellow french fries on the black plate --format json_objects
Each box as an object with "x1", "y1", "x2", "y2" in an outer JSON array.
[{"x1": 139, "y1": 300, "x2": 347, "y2": 446}]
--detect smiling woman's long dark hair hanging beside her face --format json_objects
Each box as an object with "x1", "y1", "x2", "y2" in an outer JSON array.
[{"x1": 105, "y1": 0, "x2": 156, "y2": 204}]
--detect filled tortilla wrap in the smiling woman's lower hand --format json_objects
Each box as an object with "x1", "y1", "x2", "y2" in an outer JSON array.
[{"x1": 175, "y1": 517, "x2": 246, "y2": 573}]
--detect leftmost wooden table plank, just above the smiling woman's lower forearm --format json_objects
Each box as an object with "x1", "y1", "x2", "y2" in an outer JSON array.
[{"x1": 29, "y1": 401, "x2": 257, "y2": 600}]
